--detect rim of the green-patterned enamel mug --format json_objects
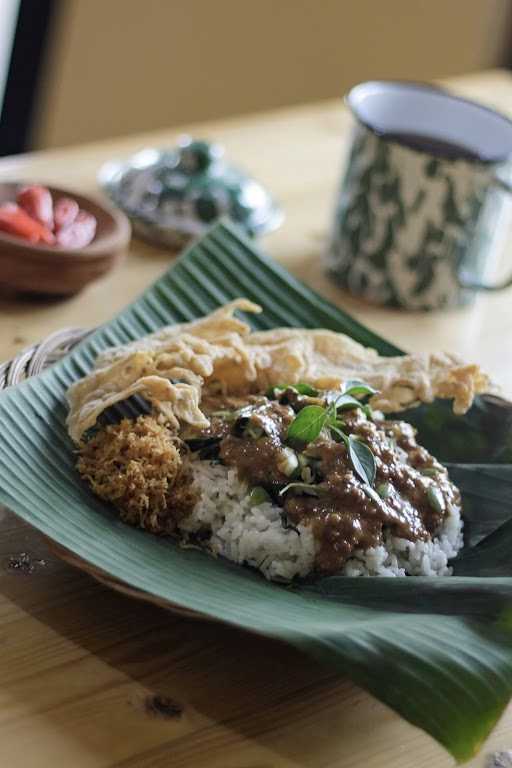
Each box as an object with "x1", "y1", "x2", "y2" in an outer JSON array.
[{"x1": 343, "y1": 80, "x2": 512, "y2": 166}]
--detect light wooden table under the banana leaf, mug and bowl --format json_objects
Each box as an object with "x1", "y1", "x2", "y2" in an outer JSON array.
[{"x1": 0, "y1": 72, "x2": 512, "y2": 768}]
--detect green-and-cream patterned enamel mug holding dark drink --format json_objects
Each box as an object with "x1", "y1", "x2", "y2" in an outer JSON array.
[{"x1": 328, "y1": 82, "x2": 512, "y2": 310}]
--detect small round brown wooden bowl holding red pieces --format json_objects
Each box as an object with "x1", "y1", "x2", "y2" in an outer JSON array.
[{"x1": 0, "y1": 182, "x2": 131, "y2": 296}]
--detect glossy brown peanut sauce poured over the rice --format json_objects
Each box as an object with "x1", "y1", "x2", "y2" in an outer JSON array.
[{"x1": 191, "y1": 396, "x2": 460, "y2": 573}]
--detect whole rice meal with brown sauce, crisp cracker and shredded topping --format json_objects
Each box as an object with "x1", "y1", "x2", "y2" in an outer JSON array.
[{"x1": 67, "y1": 299, "x2": 480, "y2": 580}]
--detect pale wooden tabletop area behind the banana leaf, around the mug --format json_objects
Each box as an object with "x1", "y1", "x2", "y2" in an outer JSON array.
[{"x1": 0, "y1": 72, "x2": 512, "y2": 395}]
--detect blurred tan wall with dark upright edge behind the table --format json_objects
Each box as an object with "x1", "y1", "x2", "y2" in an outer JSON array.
[{"x1": 0, "y1": 0, "x2": 512, "y2": 155}]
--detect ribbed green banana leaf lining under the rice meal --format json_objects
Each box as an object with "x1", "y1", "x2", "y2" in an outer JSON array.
[{"x1": 0, "y1": 223, "x2": 512, "y2": 760}]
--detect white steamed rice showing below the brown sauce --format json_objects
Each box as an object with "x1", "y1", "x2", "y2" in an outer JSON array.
[{"x1": 180, "y1": 461, "x2": 462, "y2": 581}]
